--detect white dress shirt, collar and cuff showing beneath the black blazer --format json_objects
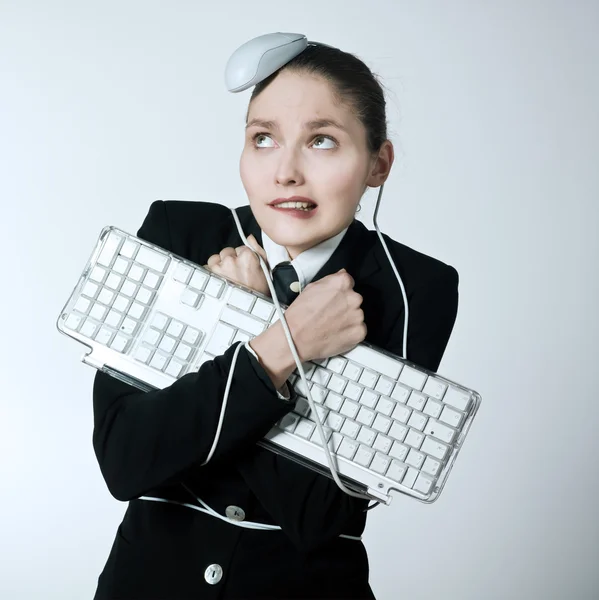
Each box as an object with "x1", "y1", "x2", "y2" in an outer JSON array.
[{"x1": 245, "y1": 227, "x2": 347, "y2": 400}]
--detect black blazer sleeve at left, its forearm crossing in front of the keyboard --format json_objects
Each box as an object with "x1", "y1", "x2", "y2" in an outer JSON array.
[{"x1": 93, "y1": 201, "x2": 295, "y2": 500}]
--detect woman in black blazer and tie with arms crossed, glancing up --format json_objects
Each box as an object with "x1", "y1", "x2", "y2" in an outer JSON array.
[{"x1": 94, "y1": 46, "x2": 458, "y2": 600}]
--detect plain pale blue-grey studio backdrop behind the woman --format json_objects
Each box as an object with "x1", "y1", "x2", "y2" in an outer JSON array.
[{"x1": 0, "y1": 0, "x2": 599, "y2": 600}]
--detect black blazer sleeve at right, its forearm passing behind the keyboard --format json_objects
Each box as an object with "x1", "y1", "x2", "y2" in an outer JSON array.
[{"x1": 238, "y1": 267, "x2": 458, "y2": 551}]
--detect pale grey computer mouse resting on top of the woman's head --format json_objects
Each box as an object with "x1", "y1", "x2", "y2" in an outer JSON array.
[{"x1": 225, "y1": 32, "x2": 308, "y2": 93}]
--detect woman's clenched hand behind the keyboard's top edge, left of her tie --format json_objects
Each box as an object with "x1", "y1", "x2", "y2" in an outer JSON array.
[{"x1": 204, "y1": 234, "x2": 270, "y2": 297}]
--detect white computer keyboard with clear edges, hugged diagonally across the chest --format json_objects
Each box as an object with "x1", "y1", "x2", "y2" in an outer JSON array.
[{"x1": 57, "y1": 227, "x2": 481, "y2": 504}]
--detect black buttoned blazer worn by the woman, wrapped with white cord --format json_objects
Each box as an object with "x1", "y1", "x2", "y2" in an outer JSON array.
[{"x1": 93, "y1": 201, "x2": 458, "y2": 600}]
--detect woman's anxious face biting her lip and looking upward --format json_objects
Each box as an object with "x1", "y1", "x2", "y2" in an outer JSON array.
[{"x1": 240, "y1": 71, "x2": 376, "y2": 259}]
